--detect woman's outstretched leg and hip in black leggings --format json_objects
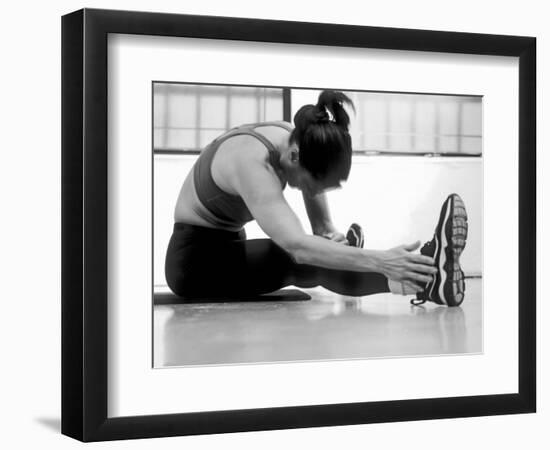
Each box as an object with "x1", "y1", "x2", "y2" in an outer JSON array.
[{"x1": 166, "y1": 225, "x2": 389, "y2": 297}]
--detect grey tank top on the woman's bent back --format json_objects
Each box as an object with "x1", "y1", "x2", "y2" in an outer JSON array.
[{"x1": 193, "y1": 122, "x2": 292, "y2": 230}]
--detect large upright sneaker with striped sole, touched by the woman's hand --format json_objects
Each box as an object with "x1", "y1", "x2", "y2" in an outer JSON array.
[{"x1": 411, "y1": 194, "x2": 468, "y2": 306}]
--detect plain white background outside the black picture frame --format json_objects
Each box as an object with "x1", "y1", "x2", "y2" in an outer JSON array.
[{"x1": 0, "y1": 0, "x2": 550, "y2": 449}]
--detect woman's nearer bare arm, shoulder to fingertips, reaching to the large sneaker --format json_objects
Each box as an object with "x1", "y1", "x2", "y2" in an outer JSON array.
[{"x1": 231, "y1": 144, "x2": 436, "y2": 282}]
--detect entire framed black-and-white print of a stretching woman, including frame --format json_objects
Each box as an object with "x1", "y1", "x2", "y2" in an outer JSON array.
[{"x1": 62, "y1": 9, "x2": 536, "y2": 441}]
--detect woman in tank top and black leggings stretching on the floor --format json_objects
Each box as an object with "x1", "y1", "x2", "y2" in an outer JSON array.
[{"x1": 165, "y1": 91, "x2": 465, "y2": 304}]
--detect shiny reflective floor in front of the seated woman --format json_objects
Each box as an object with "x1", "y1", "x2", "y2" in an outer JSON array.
[{"x1": 154, "y1": 279, "x2": 482, "y2": 367}]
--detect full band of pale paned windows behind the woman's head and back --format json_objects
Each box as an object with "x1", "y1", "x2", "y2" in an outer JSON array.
[{"x1": 153, "y1": 83, "x2": 482, "y2": 156}]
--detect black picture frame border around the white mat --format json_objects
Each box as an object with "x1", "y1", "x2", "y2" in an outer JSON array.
[{"x1": 62, "y1": 9, "x2": 536, "y2": 441}]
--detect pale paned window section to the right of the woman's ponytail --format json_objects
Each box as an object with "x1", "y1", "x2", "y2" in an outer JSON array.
[{"x1": 347, "y1": 92, "x2": 482, "y2": 156}]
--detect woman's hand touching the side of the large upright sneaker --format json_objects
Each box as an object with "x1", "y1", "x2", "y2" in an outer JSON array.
[{"x1": 380, "y1": 241, "x2": 437, "y2": 284}]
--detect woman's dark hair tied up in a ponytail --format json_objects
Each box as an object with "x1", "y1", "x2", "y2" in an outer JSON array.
[{"x1": 289, "y1": 91, "x2": 355, "y2": 182}]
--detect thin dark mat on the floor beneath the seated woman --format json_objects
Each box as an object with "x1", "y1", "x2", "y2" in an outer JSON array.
[{"x1": 154, "y1": 289, "x2": 311, "y2": 305}]
